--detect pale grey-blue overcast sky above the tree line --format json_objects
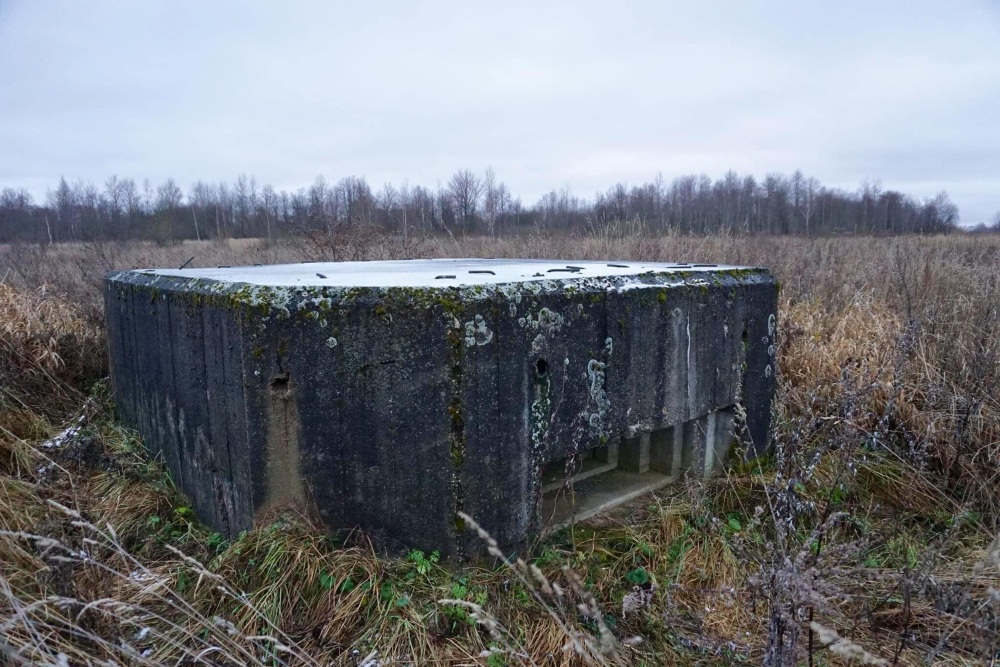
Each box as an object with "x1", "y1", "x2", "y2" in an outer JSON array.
[{"x1": 0, "y1": 0, "x2": 1000, "y2": 224}]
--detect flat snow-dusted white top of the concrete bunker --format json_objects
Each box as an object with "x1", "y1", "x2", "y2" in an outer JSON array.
[{"x1": 139, "y1": 259, "x2": 749, "y2": 287}]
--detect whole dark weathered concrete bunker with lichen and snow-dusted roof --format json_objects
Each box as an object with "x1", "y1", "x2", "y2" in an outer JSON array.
[{"x1": 106, "y1": 260, "x2": 777, "y2": 555}]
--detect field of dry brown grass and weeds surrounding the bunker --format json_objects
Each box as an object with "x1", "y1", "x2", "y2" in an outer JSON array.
[{"x1": 0, "y1": 226, "x2": 1000, "y2": 667}]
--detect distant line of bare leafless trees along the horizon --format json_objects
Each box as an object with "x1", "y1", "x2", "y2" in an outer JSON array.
[{"x1": 0, "y1": 168, "x2": 958, "y2": 243}]
